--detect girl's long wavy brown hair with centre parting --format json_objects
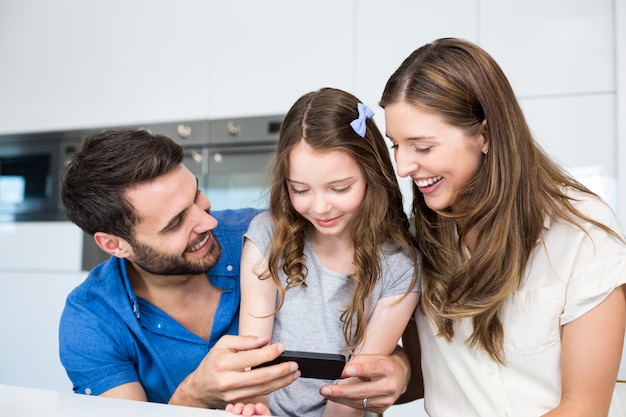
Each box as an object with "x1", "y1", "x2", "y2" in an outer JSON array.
[{"x1": 260, "y1": 88, "x2": 418, "y2": 352}]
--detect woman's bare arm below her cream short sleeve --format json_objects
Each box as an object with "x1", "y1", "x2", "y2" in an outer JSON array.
[{"x1": 544, "y1": 285, "x2": 626, "y2": 417}]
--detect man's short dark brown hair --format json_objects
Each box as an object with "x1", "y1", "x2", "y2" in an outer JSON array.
[{"x1": 61, "y1": 130, "x2": 183, "y2": 241}]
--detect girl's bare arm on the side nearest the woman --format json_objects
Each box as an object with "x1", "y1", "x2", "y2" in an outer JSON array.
[{"x1": 323, "y1": 292, "x2": 419, "y2": 417}]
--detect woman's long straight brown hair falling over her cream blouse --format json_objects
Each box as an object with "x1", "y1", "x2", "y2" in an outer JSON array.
[{"x1": 380, "y1": 38, "x2": 619, "y2": 362}]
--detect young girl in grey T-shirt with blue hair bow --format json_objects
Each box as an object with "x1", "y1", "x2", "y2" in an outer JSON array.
[{"x1": 229, "y1": 88, "x2": 418, "y2": 417}]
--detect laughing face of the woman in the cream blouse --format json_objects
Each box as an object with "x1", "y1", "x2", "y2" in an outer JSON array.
[{"x1": 385, "y1": 102, "x2": 488, "y2": 210}]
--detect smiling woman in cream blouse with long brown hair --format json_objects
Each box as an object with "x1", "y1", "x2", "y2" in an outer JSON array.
[{"x1": 381, "y1": 38, "x2": 626, "y2": 417}]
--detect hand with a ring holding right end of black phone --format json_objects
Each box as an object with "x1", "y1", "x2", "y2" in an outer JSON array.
[{"x1": 320, "y1": 347, "x2": 410, "y2": 413}]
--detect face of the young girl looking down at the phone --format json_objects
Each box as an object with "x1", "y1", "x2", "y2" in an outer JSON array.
[{"x1": 287, "y1": 141, "x2": 366, "y2": 238}]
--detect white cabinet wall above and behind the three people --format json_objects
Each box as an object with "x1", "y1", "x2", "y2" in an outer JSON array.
[{"x1": 0, "y1": 0, "x2": 626, "y2": 415}]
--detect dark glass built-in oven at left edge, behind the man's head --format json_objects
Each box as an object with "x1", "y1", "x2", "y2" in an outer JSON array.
[{"x1": 0, "y1": 131, "x2": 81, "y2": 222}]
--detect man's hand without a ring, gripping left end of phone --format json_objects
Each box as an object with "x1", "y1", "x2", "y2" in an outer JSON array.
[{"x1": 169, "y1": 336, "x2": 300, "y2": 408}]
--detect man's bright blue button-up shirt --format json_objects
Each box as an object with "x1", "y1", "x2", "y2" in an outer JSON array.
[{"x1": 59, "y1": 209, "x2": 260, "y2": 403}]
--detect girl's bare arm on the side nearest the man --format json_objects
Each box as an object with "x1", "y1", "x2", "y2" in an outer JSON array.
[{"x1": 227, "y1": 239, "x2": 277, "y2": 416}]
